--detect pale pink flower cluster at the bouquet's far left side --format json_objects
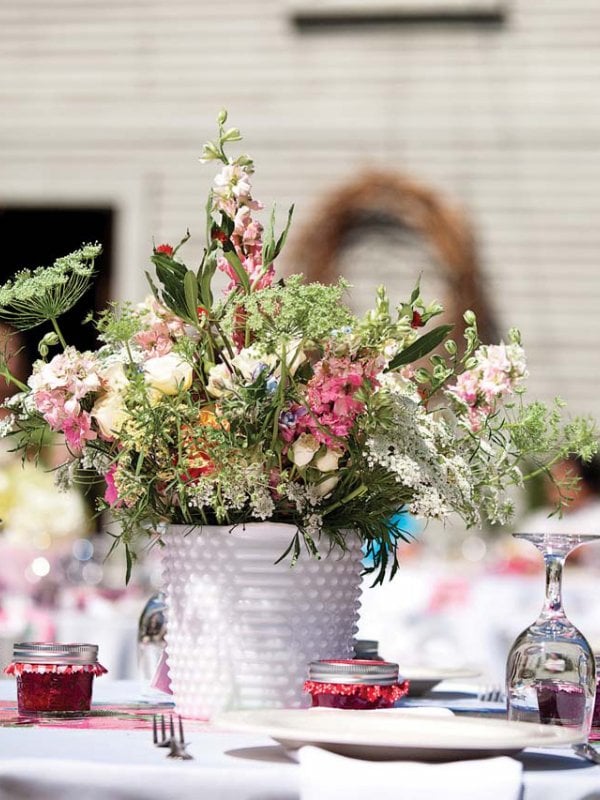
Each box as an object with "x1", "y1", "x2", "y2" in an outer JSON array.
[{"x1": 28, "y1": 347, "x2": 102, "y2": 452}]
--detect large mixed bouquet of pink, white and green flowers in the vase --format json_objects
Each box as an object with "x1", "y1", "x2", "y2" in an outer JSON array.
[{"x1": 0, "y1": 111, "x2": 597, "y2": 580}]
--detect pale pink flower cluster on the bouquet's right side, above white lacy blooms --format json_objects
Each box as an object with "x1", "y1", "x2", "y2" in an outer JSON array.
[{"x1": 448, "y1": 344, "x2": 527, "y2": 432}]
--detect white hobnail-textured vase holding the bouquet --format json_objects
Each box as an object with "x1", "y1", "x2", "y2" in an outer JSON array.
[{"x1": 163, "y1": 523, "x2": 362, "y2": 719}]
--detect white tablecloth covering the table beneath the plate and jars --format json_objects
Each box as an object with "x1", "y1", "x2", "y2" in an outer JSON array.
[{"x1": 0, "y1": 679, "x2": 600, "y2": 800}]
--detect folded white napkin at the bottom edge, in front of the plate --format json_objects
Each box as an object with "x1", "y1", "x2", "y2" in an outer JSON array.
[{"x1": 298, "y1": 746, "x2": 522, "y2": 800}]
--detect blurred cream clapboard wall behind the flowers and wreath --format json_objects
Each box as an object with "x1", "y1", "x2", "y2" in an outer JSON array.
[{"x1": 0, "y1": 0, "x2": 600, "y2": 414}]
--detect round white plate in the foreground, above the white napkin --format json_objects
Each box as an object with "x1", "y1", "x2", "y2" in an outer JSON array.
[{"x1": 215, "y1": 708, "x2": 581, "y2": 761}]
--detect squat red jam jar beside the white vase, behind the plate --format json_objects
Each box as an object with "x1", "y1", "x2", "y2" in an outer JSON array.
[{"x1": 304, "y1": 659, "x2": 408, "y2": 710}]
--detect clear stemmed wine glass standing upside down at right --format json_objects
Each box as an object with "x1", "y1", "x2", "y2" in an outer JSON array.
[{"x1": 506, "y1": 533, "x2": 600, "y2": 740}]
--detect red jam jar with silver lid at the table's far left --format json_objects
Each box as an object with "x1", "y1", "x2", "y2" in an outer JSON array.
[{"x1": 4, "y1": 642, "x2": 106, "y2": 717}]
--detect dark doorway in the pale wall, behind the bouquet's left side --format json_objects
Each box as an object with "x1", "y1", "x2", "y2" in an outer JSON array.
[{"x1": 0, "y1": 206, "x2": 114, "y2": 363}]
